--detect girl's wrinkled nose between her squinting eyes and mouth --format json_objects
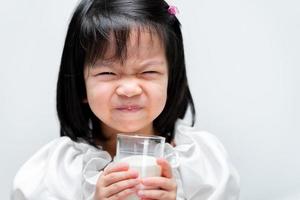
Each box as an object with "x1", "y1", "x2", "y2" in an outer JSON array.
[{"x1": 116, "y1": 79, "x2": 142, "y2": 97}]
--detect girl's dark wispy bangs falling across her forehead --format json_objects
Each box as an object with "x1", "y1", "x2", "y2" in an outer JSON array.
[{"x1": 79, "y1": 15, "x2": 167, "y2": 66}]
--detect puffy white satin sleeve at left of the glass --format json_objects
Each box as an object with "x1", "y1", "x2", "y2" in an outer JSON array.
[{"x1": 11, "y1": 137, "x2": 111, "y2": 200}]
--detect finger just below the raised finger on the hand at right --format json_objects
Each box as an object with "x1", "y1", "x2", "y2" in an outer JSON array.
[{"x1": 142, "y1": 177, "x2": 177, "y2": 191}]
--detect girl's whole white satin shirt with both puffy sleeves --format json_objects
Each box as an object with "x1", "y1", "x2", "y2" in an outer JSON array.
[{"x1": 11, "y1": 120, "x2": 239, "y2": 200}]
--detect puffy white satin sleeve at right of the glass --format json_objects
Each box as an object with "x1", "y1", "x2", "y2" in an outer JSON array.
[{"x1": 173, "y1": 121, "x2": 240, "y2": 200}]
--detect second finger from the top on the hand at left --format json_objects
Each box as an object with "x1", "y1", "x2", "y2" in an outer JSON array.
[{"x1": 102, "y1": 169, "x2": 139, "y2": 187}]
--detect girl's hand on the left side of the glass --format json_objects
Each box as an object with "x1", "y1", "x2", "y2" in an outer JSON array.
[{"x1": 94, "y1": 163, "x2": 140, "y2": 200}]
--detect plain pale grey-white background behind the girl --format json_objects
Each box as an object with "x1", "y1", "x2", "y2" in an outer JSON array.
[{"x1": 0, "y1": 0, "x2": 300, "y2": 200}]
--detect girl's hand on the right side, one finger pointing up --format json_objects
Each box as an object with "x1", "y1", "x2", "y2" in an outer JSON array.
[{"x1": 137, "y1": 158, "x2": 177, "y2": 200}]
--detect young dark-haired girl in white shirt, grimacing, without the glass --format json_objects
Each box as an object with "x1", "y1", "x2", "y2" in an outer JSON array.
[{"x1": 11, "y1": 0, "x2": 239, "y2": 200}]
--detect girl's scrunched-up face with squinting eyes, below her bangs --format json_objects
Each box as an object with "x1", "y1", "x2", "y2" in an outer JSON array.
[{"x1": 84, "y1": 31, "x2": 168, "y2": 136}]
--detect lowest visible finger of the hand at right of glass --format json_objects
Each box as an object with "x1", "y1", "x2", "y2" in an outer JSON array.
[{"x1": 137, "y1": 190, "x2": 176, "y2": 200}]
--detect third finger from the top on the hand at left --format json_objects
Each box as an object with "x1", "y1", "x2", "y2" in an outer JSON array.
[{"x1": 105, "y1": 179, "x2": 141, "y2": 197}]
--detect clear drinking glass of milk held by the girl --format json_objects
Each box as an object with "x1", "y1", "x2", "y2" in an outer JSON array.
[{"x1": 115, "y1": 134, "x2": 165, "y2": 200}]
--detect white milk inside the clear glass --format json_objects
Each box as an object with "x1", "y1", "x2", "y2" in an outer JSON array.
[{"x1": 120, "y1": 155, "x2": 161, "y2": 200}]
